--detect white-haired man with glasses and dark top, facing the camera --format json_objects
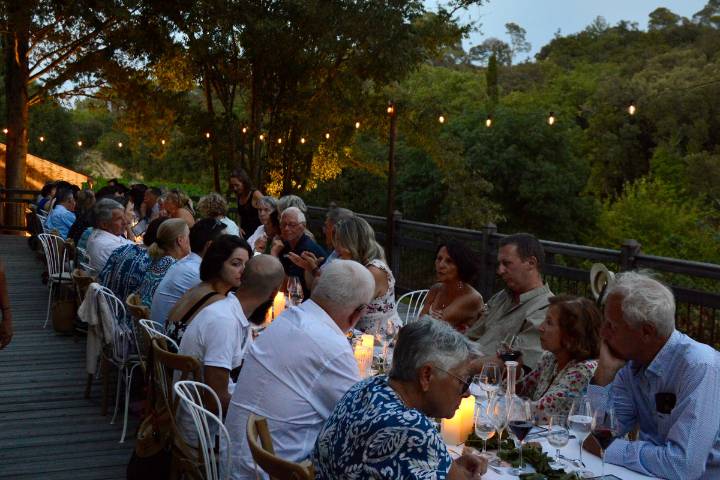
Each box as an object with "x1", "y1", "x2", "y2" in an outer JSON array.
[{"x1": 271, "y1": 207, "x2": 327, "y2": 298}]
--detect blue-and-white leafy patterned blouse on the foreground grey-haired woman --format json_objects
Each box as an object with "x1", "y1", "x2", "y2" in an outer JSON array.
[{"x1": 312, "y1": 375, "x2": 452, "y2": 480}]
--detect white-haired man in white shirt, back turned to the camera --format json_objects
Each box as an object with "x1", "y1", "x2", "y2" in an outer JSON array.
[{"x1": 222, "y1": 260, "x2": 375, "y2": 479}]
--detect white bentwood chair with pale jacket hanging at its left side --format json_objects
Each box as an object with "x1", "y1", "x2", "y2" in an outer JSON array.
[{"x1": 97, "y1": 286, "x2": 140, "y2": 443}]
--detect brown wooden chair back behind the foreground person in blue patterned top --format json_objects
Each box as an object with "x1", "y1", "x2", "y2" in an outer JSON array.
[{"x1": 247, "y1": 413, "x2": 315, "y2": 480}]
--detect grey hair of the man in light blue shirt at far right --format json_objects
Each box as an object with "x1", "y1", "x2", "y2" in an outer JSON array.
[{"x1": 606, "y1": 272, "x2": 675, "y2": 337}]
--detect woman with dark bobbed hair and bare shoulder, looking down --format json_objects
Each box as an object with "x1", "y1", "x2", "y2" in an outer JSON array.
[{"x1": 166, "y1": 235, "x2": 252, "y2": 344}]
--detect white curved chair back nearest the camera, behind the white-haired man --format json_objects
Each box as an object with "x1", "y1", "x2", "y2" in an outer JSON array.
[{"x1": 173, "y1": 380, "x2": 231, "y2": 480}]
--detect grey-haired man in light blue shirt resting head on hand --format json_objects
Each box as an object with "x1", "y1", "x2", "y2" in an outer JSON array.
[{"x1": 585, "y1": 272, "x2": 720, "y2": 480}]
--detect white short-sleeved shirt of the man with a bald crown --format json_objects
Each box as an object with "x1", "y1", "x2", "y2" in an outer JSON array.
[{"x1": 175, "y1": 294, "x2": 252, "y2": 445}]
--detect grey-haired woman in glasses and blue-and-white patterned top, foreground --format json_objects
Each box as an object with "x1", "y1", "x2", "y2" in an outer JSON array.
[{"x1": 312, "y1": 319, "x2": 487, "y2": 480}]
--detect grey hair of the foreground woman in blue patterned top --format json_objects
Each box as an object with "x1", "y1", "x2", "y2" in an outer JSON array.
[{"x1": 389, "y1": 317, "x2": 476, "y2": 381}]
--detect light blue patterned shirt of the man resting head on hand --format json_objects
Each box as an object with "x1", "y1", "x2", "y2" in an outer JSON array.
[{"x1": 588, "y1": 331, "x2": 720, "y2": 480}]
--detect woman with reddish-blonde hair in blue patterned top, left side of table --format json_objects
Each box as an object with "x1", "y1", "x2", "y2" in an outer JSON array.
[{"x1": 138, "y1": 218, "x2": 190, "y2": 307}]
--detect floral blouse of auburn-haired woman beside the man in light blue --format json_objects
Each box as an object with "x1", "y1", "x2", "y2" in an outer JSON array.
[{"x1": 517, "y1": 352, "x2": 597, "y2": 417}]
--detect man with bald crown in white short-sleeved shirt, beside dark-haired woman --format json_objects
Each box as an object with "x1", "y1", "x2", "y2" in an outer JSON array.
[{"x1": 176, "y1": 255, "x2": 285, "y2": 445}]
